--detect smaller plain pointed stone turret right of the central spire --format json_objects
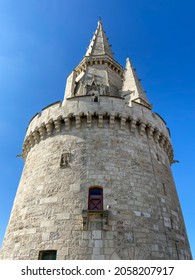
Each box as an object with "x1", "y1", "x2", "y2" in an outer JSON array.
[{"x1": 122, "y1": 58, "x2": 151, "y2": 109}]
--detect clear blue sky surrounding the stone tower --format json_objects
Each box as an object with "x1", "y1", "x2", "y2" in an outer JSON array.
[{"x1": 0, "y1": 0, "x2": 195, "y2": 257}]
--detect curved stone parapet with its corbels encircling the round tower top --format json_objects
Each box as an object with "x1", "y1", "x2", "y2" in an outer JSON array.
[{"x1": 23, "y1": 97, "x2": 173, "y2": 164}]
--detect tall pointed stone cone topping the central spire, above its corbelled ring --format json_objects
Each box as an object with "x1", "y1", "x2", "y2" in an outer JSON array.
[{"x1": 85, "y1": 20, "x2": 113, "y2": 58}]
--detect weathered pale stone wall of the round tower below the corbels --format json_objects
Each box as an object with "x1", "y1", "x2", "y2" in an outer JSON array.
[{"x1": 2, "y1": 115, "x2": 190, "y2": 259}]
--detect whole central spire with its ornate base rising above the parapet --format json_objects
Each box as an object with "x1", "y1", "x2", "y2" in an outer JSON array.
[{"x1": 64, "y1": 19, "x2": 123, "y2": 102}]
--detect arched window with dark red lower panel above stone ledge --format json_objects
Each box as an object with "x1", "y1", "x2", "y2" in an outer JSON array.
[{"x1": 88, "y1": 188, "x2": 103, "y2": 211}]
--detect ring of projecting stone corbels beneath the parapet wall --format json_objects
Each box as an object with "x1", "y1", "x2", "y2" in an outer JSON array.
[{"x1": 23, "y1": 111, "x2": 173, "y2": 164}]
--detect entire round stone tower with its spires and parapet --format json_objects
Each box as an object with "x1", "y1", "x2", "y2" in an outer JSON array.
[{"x1": 1, "y1": 21, "x2": 191, "y2": 260}]
